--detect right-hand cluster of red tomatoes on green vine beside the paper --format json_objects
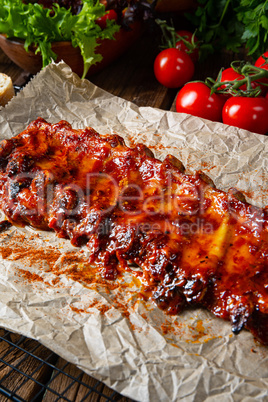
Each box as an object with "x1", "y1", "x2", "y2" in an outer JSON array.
[{"x1": 176, "y1": 52, "x2": 268, "y2": 134}]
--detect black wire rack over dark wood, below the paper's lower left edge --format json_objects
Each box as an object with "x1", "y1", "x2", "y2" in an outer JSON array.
[{"x1": 0, "y1": 328, "x2": 131, "y2": 402}]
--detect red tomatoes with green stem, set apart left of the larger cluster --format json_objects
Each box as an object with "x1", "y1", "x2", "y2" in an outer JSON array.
[{"x1": 154, "y1": 20, "x2": 199, "y2": 88}]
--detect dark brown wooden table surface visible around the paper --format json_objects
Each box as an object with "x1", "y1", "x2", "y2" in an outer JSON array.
[{"x1": 0, "y1": 20, "x2": 239, "y2": 402}]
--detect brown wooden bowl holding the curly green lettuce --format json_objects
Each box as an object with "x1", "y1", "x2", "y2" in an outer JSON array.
[{"x1": 0, "y1": 21, "x2": 142, "y2": 77}]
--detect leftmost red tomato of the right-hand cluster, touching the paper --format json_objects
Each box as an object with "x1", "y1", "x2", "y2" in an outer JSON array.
[{"x1": 176, "y1": 82, "x2": 226, "y2": 121}]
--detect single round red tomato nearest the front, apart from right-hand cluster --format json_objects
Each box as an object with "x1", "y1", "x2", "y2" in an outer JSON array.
[{"x1": 154, "y1": 48, "x2": 194, "y2": 88}]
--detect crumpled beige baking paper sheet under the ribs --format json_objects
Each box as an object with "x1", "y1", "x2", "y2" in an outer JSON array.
[{"x1": 0, "y1": 63, "x2": 268, "y2": 402}]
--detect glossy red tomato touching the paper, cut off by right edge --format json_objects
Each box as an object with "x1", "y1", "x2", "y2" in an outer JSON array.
[{"x1": 222, "y1": 96, "x2": 268, "y2": 134}]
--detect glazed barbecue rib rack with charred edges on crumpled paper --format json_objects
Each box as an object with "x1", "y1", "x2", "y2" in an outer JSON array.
[{"x1": 0, "y1": 118, "x2": 268, "y2": 345}]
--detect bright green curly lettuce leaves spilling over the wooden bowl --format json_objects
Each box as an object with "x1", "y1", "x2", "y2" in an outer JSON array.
[{"x1": 0, "y1": 0, "x2": 120, "y2": 78}]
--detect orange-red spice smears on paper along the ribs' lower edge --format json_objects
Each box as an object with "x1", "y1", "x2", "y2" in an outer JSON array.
[{"x1": 0, "y1": 230, "x2": 224, "y2": 344}]
